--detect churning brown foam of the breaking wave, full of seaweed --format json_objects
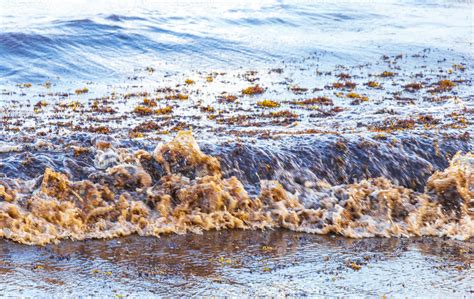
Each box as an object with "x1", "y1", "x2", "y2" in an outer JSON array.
[{"x1": 0, "y1": 131, "x2": 474, "y2": 245}]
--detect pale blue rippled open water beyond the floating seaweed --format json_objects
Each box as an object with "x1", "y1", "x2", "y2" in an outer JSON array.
[{"x1": 0, "y1": 0, "x2": 473, "y2": 85}]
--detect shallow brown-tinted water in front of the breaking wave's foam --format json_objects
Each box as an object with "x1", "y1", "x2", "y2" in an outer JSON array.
[{"x1": 0, "y1": 230, "x2": 474, "y2": 297}]
